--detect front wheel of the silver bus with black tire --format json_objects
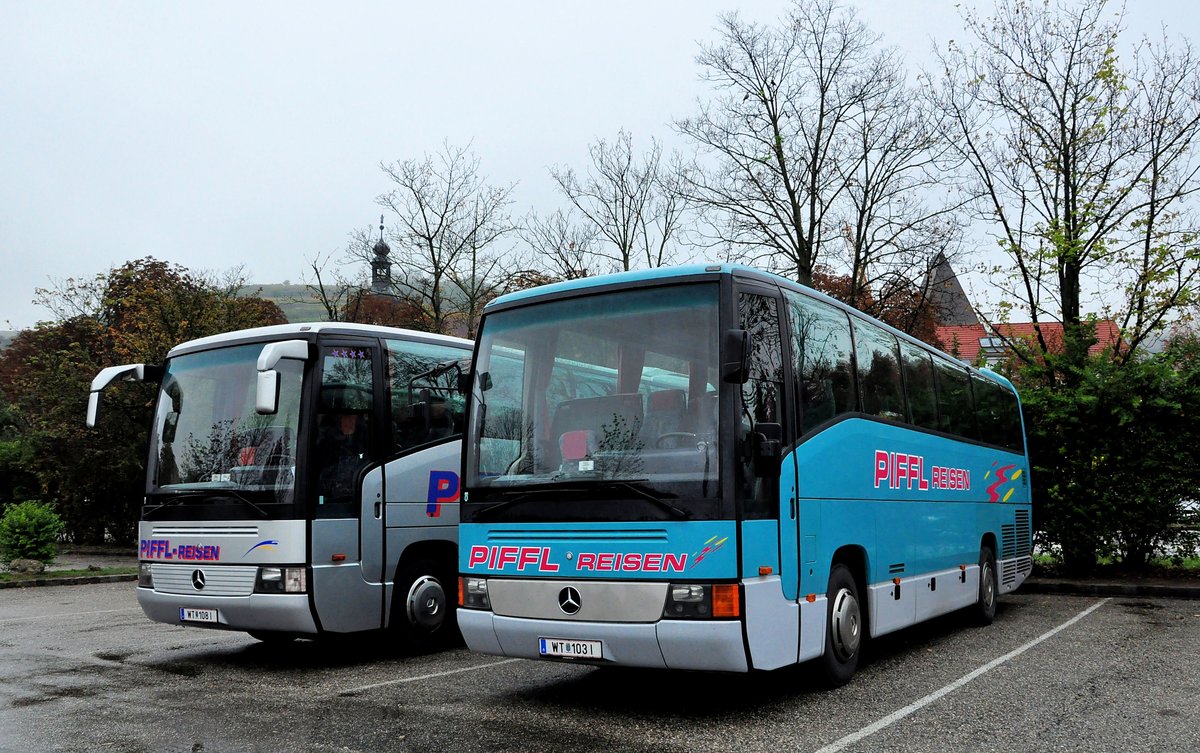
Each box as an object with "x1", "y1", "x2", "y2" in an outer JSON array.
[{"x1": 391, "y1": 559, "x2": 460, "y2": 651}]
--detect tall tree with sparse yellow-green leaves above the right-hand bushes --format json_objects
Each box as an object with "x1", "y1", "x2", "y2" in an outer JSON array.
[{"x1": 940, "y1": 0, "x2": 1200, "y2": 357}]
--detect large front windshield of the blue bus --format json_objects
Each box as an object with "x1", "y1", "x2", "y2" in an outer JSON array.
[{"x1": 463, "y1": 283, "x2": 720, "y2": 519}]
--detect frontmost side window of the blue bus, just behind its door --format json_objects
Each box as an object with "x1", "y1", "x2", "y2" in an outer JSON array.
[{"x1": 784, "y1": 290, "x2": 857, "y2": 435}]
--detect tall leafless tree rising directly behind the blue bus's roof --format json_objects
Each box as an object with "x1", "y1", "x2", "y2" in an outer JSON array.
[{"x1": 676, "y1": 1, "x2": 878, "y2": 284}]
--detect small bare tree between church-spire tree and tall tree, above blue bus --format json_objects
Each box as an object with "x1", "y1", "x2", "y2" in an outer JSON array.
[{"x1": 550, "y1": 129, "x2": 689, "y2": 270}]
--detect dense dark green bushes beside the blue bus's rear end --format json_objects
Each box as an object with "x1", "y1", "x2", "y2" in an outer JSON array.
[{"x1": 1021, "y1": 335, "x2": 1200, "y2": 571}]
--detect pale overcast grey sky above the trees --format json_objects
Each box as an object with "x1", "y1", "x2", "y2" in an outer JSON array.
[{"x1": 0, "y1": 0, "x2": 1198, "y2": 329}]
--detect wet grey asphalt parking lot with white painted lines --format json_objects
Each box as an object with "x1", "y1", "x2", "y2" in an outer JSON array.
[{"x1": 0, "y1": 583, "x2": 1200, "y2": 753}]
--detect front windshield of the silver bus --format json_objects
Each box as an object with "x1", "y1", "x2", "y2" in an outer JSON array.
[{"x1": 146, "y1": 344, "x2": 304, "y2": 505}]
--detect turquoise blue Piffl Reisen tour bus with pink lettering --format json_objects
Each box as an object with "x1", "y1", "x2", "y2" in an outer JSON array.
[{"x1": 458, "y1": 265, "x2": 1032, "y2": 685}]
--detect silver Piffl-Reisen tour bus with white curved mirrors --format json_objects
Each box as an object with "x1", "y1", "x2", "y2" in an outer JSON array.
[{"x1": 88, "y1": 323, "x2": 472, "y2": 647}]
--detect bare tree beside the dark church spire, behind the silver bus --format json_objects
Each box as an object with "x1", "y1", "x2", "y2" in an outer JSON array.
[{"x1": 367, "y1": 144, "x2": 512, "y2": 332}]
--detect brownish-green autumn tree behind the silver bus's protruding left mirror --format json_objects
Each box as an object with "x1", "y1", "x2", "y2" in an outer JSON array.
[{"x1": 0, "y1": 258, "x2": 286, "y2": 543}]
